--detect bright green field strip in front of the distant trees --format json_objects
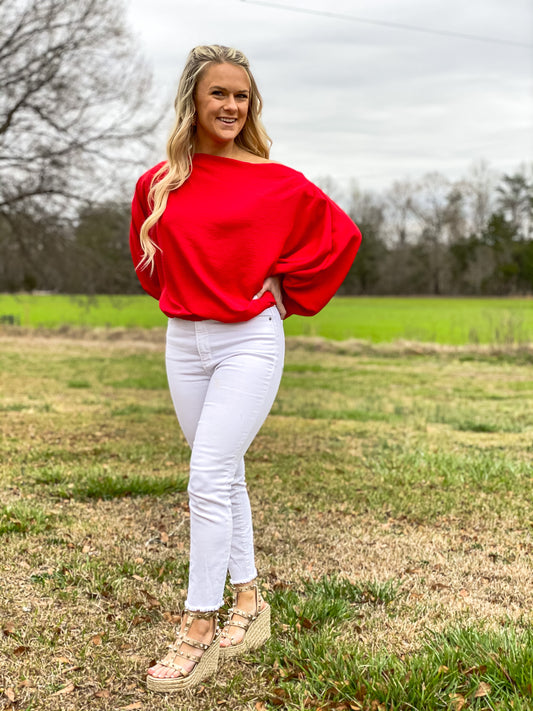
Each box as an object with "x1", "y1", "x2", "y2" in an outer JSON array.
[{"x1": 0, "y1": 294, "x2": 533, "y2": 345}]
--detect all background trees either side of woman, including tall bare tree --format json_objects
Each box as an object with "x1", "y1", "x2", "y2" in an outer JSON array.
[{"x1": 0, "y1": 0, "x2": 533, "y2": 295}]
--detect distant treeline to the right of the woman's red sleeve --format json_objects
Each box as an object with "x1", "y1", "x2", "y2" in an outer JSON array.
[{"x1": 342, "y1": 164, "x2": 533, "y2": 295}]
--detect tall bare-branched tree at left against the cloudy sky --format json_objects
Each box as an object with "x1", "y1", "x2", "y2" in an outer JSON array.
[{"x1": 0, "y1": 0, "x2": 159, "y2": 290}]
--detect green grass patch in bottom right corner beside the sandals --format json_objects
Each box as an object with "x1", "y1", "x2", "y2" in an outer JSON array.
[{"x1": 265, "y1": 581, "x2": 533, "y2": 711}]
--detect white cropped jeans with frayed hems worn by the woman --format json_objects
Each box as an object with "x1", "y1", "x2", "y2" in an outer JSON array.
[{"x1": 166, "y1": 306, "x2": 285, "y2": 612}]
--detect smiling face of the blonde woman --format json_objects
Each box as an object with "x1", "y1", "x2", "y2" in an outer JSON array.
[{"x1": 195, "y1": 64, "x2": 250, "y2": 153}]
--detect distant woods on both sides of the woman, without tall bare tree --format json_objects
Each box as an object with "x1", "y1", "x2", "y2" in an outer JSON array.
[{"x1": 0, "y1": 165, "x2": 533, "y2": 295}]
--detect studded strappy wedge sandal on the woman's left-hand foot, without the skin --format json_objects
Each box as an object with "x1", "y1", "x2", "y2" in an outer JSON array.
[{"x1": 146, "y1": 610, "x2": 220, "y2": 693}]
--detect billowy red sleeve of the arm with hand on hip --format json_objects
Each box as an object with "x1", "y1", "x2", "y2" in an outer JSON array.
[{"x1": 273, "y1": 183, "x2": 361, "y2": 316}]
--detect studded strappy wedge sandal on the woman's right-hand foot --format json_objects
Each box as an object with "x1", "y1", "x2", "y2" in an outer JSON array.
[{"x1": 220, "y1": 581, "x2": 270, "y2": 660}]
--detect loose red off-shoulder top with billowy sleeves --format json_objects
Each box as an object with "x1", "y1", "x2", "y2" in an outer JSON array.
[{"x1": 130, "y1": 153, "x2": 361, "y2": 323}]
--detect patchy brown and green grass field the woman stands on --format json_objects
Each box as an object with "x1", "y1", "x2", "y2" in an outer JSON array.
[{"x1": 0, "y1": 330, "x2": 533, "y2": 711}]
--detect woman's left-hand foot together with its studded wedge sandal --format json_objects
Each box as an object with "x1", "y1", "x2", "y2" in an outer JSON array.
[{"x1": 147, "y1": 610, "x2": 220, "y2": 691}]
